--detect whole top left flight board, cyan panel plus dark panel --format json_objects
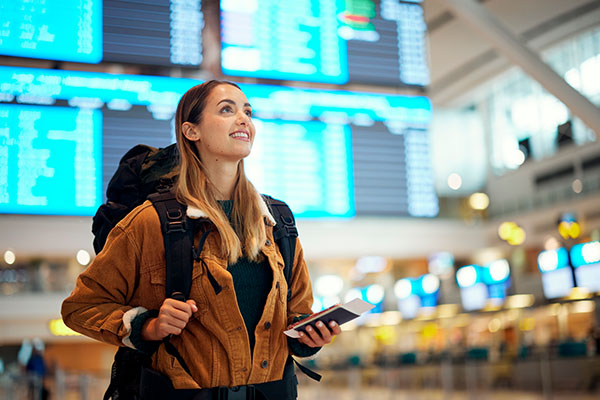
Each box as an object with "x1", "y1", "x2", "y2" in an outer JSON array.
[{"x1": 0, "y1": 0, "x2": 204, "y2": 67}]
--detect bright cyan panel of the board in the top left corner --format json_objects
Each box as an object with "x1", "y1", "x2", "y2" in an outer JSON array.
[{"x1": 0, "y1": 0, "x2": 102, "y2": 63}]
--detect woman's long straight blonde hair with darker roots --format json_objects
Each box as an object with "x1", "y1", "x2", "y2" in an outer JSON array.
[{"x1": 175, "y1": 80, "x2": 267, "y2": 264}]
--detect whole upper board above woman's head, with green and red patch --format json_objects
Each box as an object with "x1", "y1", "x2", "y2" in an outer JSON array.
[{"x1": 220, "y1": 0, "x2": 429, "y2": 86}]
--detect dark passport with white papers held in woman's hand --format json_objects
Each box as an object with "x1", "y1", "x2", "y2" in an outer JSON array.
[{"x1": 283, "y1": 299, "x2": 375, "y2": 338}]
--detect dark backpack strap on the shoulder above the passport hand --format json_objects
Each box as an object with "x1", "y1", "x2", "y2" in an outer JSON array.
[{"x1": 263, "y1": 195, "x2": 298, "y2": 301}]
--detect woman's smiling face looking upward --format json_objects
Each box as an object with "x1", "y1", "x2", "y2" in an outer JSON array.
[{"x1": 183, "y1": 84, "x2": 255, "y2": 163}]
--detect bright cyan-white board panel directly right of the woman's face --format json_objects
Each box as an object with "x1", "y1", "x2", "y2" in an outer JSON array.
[{"x1": 244, "y1": 119, "x2": 355, "y2": 218}]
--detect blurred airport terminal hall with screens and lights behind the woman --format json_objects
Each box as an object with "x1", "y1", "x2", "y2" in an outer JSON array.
[{"x1": 0, "y1": 0, "x2": 600, "y2": 399}]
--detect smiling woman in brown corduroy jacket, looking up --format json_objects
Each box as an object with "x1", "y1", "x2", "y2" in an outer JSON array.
[{"x1": 62, "y1": 81, "x2": 340, "y2": 399}]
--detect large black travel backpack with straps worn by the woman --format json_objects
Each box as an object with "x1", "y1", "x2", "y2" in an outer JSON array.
[{"x1": 92, "y1": 144, "x2": 310, "y2": 400}]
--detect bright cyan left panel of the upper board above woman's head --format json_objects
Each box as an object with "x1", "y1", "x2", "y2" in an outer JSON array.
[{"x1": 221, "y1": 0, "x2": 348, "y2": 83}]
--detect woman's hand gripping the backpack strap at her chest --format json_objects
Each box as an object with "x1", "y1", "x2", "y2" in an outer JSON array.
[{"x1": 142, "y1": 298, "x2": 198, "y2": 341}]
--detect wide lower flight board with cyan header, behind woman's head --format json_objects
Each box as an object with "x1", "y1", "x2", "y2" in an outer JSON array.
[{"x1": 0, "y1": 67, "x2": 438, "y2": 218}]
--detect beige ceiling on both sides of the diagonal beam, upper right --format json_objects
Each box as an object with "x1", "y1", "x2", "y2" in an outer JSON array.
[{"x1": 423, "y1": 0, "x2": 600, "y2": 107}]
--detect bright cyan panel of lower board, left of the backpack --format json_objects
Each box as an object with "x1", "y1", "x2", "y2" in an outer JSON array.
[{"x1": 0, "y1": 104, "x2": 102, "y2": 215}]
